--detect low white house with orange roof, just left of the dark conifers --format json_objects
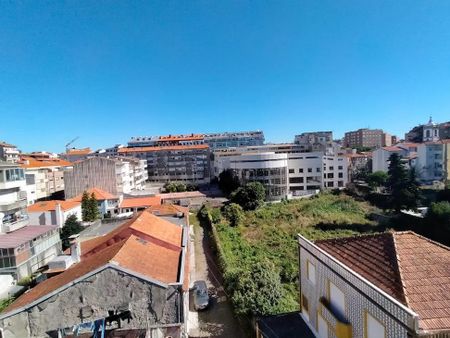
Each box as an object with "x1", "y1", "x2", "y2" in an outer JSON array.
[{"x1": 27, "y1": 200, "x2": 82, "y2": 228}]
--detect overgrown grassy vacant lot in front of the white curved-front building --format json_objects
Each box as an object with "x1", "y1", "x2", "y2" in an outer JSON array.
[{"x1": 216, "y1": 194, "x2": 380, "y2": 313}]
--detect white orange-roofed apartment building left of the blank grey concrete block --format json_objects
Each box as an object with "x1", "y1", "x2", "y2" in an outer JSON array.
[{"x1": 20, "y1": 155, "x2": 72, "y2": 205}]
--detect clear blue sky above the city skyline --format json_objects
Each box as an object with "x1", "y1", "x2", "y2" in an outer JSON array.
[{"x1": 0, "y1": 0, "x2": 450, "y2": 151}]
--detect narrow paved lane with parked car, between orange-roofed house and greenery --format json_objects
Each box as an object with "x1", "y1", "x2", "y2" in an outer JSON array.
[{"x1": 189, "y1": 226, "x2": 245, "y2": 338}]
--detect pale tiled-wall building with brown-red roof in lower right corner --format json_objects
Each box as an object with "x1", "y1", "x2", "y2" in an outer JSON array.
[{"x1": 292, "y1": 231, "x2": 450, "y2": 338}]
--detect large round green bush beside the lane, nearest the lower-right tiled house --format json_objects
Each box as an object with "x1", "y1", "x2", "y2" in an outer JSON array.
[{"x1": 226, "y1": 260, "x2": 283, "y2": 316}]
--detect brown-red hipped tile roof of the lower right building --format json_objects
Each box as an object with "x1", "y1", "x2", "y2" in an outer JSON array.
[{"x1": 315, "y1": 231, "x2": 450, "y2": 332}]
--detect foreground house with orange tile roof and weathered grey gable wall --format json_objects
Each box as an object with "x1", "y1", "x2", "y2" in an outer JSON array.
[{"x1": 0, "y1": 211, "x2": 189, "y2": 338}]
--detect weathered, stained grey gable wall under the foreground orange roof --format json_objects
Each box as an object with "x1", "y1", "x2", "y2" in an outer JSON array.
[{"x1": 0, "y1": 268, "x2": 182, "y2": 338}]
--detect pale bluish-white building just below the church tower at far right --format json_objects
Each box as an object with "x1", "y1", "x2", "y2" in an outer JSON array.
[{"x1": 416, "y1": 142, "x2": 445, "y2": 183}]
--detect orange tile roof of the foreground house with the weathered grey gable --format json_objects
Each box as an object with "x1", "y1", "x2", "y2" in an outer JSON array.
[{"x1": 4, "y1": 211, "x2": 188, "y2": 312}]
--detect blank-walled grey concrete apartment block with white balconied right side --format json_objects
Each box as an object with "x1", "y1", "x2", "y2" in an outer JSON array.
[{"x1": 64, "y1": 157, "x2": 147, "y2": 199}]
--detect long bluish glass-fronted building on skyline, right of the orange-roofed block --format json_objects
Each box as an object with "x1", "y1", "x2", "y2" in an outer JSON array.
[{"x1": 204, "y1": 131, "x2": 264, "y2": 151}]
